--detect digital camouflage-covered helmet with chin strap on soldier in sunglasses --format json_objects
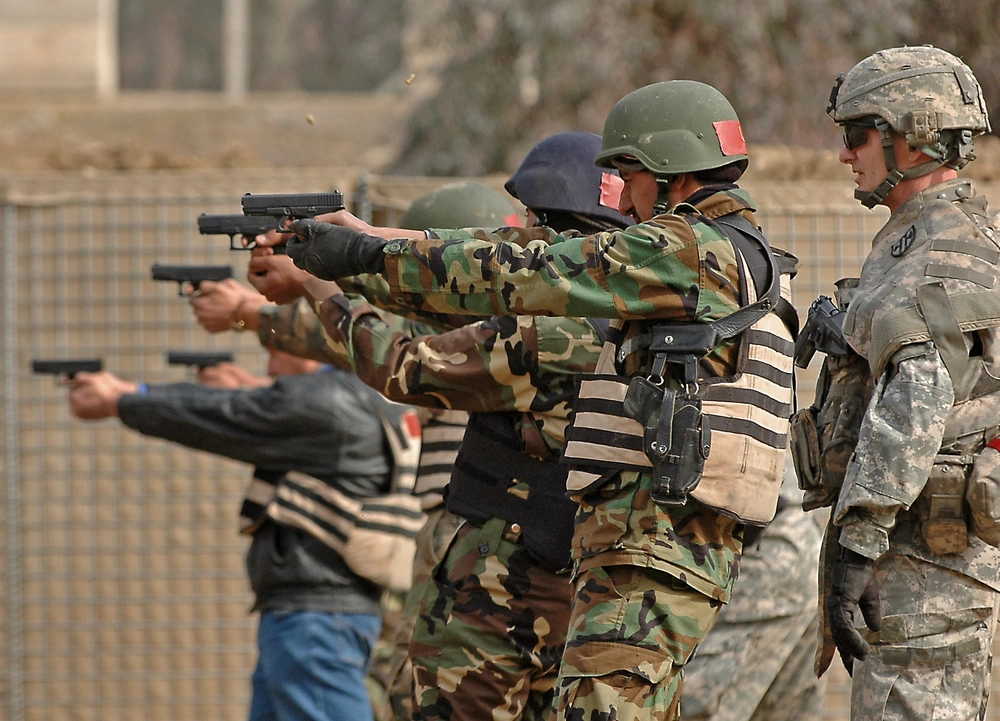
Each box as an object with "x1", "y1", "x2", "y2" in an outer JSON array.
[{"x1": 827, "y1": 45, "x2": 990, "y2": 208}]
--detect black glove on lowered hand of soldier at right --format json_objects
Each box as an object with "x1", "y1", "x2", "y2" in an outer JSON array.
[{"x1": 826, "y1": 548, "x2": 882, "y2": 674}]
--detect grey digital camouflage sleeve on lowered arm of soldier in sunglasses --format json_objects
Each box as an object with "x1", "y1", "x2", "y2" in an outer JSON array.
[{"x1": 834, "y1": 343, "x2": 955, "y2": 558}]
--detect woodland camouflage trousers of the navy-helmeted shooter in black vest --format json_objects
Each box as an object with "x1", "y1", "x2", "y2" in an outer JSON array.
[{"x1": 410, "y1": 519, "x2": 572, "y2": 721}]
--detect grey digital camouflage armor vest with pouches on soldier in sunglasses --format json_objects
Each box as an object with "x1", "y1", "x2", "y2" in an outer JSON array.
[{"x1": 844, "y1": 180, "x2": 1000, "y2": 556}]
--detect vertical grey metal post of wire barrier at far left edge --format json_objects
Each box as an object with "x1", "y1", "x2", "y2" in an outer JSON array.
[{"x1": 2, "y1": 204, "x2": 24, "y2": 721}]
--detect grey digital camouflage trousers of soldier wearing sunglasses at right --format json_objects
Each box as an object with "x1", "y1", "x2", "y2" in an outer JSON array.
[{"x1": 851, "y1": 553, "x2": 1000, "y2": 721}]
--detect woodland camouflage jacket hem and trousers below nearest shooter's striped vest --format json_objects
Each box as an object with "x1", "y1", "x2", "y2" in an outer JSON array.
[{"x1": 553, "y1": 473, "x2": 742, "y2": 721}]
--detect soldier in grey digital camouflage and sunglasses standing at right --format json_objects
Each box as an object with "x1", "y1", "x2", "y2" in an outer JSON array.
[{"x1": 797, "y1": 46, "x2": 1000, "y2": 719}]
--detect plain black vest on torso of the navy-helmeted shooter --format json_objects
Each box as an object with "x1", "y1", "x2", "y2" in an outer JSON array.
[{"x1": 445, "y1": 413, "x2": 577, "y2": 571}]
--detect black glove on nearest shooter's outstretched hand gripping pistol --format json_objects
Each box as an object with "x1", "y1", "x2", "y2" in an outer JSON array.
[{"x1": 288, "y1": 218, "x2": 385, "y2": 280}]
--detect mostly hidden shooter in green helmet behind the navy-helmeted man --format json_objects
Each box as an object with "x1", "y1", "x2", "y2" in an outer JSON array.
[{"x1": 191, "y1": 183, "x2": 504, "y2": 721}]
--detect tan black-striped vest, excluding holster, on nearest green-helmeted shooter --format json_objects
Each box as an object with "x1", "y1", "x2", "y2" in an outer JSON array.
[{"x1": 563, "y1": 216, "x2": 797, "y2": 526}]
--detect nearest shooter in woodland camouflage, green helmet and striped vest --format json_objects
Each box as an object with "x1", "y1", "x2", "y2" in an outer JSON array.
[{"x1": 278, "y1": 81, "x2": 791, "y2": 721}]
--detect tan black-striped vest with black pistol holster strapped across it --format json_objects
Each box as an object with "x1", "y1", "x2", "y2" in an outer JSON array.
[{"x1": 563, "y1": 216, "x2": 797, "y2": 526}]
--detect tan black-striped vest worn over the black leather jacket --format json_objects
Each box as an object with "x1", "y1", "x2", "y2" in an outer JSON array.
[{"x1": 240, "y1": 399, "x2": 424, "y2": 591}]
